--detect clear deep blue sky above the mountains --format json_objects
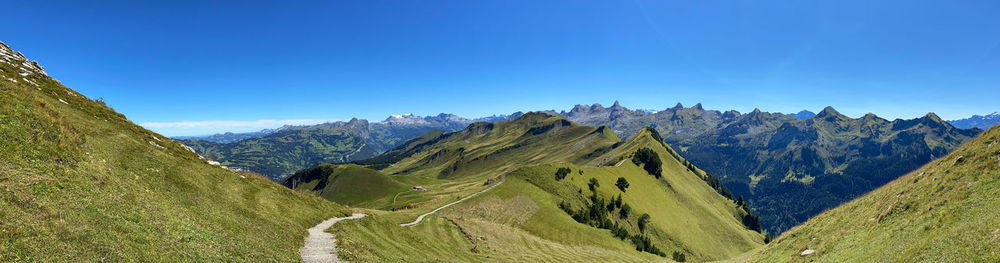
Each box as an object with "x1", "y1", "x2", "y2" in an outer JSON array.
[{"x1": 0, "y1": 0, "x2": 1000, "y2": 136}]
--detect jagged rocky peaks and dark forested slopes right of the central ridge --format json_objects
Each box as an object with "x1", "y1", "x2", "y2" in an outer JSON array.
[{"x1": 561, "y1": 103, "x2": 980, "y2": 233}]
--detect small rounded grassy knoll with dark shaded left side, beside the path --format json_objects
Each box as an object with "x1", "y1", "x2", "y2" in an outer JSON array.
[{"x1": 284, "y1": 164, "x2": 409, "y2": 208}]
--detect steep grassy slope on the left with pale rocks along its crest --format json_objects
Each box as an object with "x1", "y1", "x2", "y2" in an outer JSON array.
[{"x1": 0, "y1": 40, "x2": 348, "y2": 262}]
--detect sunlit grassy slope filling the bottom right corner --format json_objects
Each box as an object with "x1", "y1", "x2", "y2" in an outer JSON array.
[{"x1": 751, "y1": 127, "x2": 1000, "y2": 262}]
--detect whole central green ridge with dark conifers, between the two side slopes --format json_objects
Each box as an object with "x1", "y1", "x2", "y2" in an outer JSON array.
[{"x1": 284, "y1": 112, "x2": 765, "y2": 262}]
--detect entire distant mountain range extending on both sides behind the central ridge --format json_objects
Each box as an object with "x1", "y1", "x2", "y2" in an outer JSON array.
[{"x1": 182, "y1": 101, "x2": 979, "y2": 233}]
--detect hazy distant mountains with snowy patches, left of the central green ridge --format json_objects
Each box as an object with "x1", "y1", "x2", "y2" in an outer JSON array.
[{"x1": 181, "y1": 113, "x2": 482, "y2": 181}]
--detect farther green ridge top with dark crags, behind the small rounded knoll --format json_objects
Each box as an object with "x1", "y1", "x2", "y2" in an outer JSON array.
[{"x1": 383, "y1": 113, "x2": 619, "y2": 179}]
